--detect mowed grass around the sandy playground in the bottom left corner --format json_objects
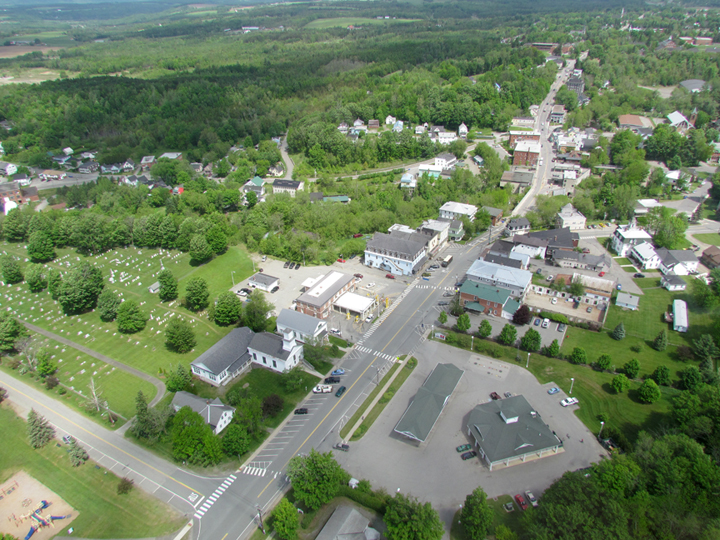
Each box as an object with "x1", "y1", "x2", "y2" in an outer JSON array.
[{"x1": 0, "y1": 406, "x2": 186, "y2": 538}]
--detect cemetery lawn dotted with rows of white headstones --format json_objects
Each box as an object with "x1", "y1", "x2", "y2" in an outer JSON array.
[{"x1": 0, "y1": 243, "x2": 252, "y2": 376}]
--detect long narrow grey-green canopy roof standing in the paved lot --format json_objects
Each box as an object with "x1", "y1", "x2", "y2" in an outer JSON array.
[{"x1": 395, "y1": 364, "x2": 465, "y2": 442}]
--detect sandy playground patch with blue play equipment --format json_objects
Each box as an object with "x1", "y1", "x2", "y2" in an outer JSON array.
[{"x1": 0, "y1": 471, "x2": 77, "y2": 540}]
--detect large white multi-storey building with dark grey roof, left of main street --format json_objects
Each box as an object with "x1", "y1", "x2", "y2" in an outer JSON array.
[{"x1": 365, "y1": 232, "x2": 427, "y2": 276}]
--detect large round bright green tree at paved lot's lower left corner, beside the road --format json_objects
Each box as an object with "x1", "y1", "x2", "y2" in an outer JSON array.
[{"x1": 287, "y1": 448, "x2": 346, "y2": 510}]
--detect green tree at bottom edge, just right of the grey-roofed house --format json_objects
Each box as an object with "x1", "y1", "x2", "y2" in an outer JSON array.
[{"x1": 384, "y1": 493, "x2": 445, "y2": 540}]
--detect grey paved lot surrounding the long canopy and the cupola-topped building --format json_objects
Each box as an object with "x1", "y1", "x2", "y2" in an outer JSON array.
[{"x1": 335, "y1": 341, "x2": 606, "y2": 530}]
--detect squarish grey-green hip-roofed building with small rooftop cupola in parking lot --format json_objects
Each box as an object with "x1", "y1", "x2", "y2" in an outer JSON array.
[{"x1": 467, "y1": 396, "x2": 563, "y2": 470}]
